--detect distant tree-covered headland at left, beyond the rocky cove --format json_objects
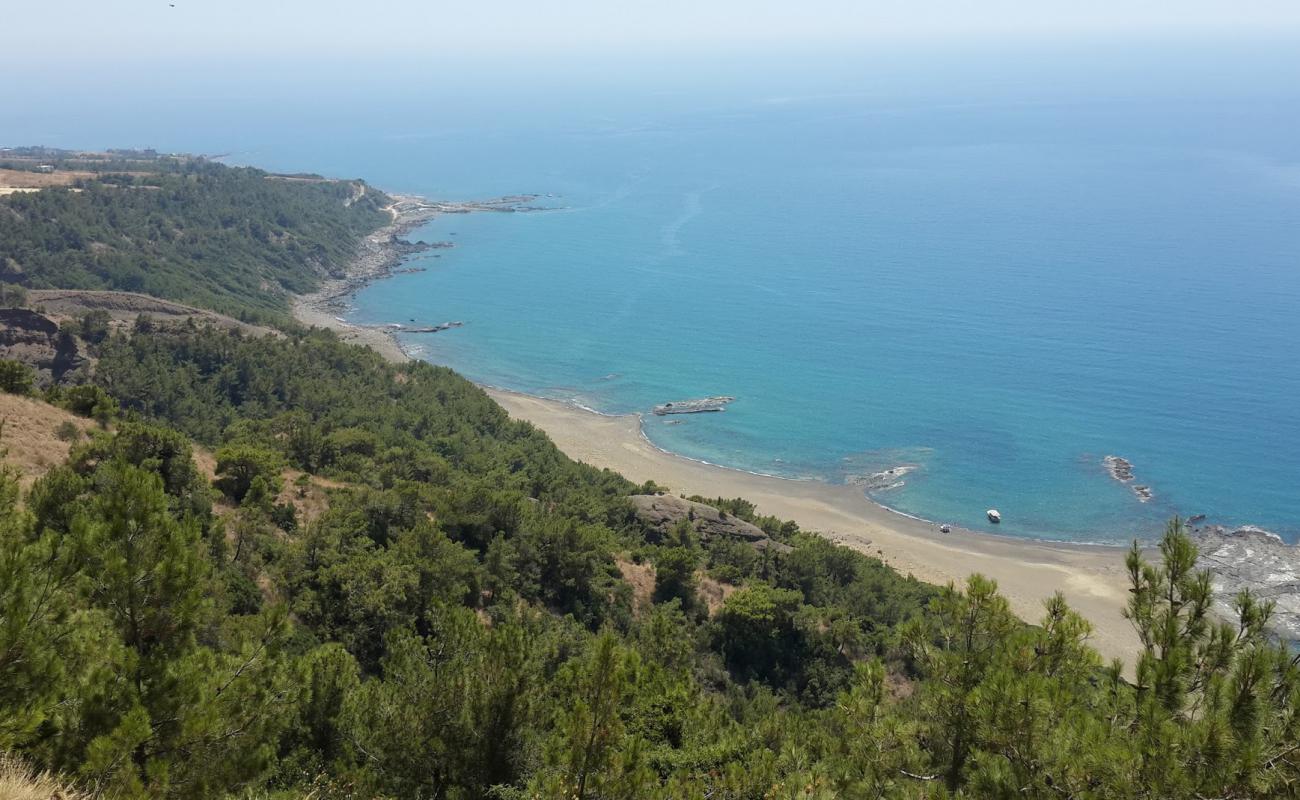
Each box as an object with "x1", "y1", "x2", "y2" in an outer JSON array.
[{"x1": 0, "y1": 159, "x2": 389, "y2": 319}]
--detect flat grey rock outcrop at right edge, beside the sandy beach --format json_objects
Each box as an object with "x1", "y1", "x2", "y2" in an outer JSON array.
[{"x1": 1192, "y1": 526, "x2": 1300, "y2": 641}]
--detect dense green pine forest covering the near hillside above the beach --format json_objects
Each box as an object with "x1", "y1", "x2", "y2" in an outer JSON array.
[{"x1": 0, "y1": 327, "x2": 1300, "y2": 799}]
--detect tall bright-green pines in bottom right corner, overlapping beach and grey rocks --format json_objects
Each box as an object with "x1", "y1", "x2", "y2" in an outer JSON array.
[{"x1": 1125, "y1": 518, "x2": 1300, "y2": 796}]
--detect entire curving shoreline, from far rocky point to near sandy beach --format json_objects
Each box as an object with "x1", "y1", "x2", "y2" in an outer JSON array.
[{"x1": 293, "y1": 195, "x2": 1140, "y2": 673}]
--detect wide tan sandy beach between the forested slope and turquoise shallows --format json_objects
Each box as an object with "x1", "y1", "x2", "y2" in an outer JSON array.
[{"x1": 488, "y1": 389, "x2": 1139, "y2": 666}]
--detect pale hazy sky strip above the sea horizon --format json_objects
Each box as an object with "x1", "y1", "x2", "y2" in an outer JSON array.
[{"x1": 0, "y1": 0, "x2": 1300, "y2": 65}]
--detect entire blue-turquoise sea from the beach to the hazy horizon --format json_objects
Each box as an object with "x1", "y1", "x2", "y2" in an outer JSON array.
[{"x1": 10, "y1": 43, "x2": 1300, "y2": 542}]
